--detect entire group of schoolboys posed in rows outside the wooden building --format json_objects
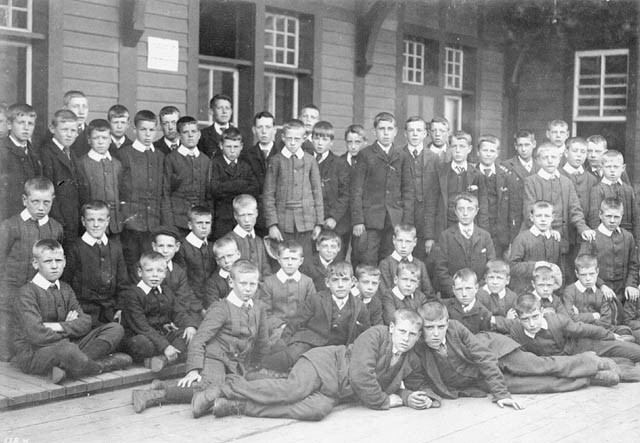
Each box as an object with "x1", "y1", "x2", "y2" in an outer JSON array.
[{"x1": 0, "y1": 91, "x2": 640, "y2": 420}]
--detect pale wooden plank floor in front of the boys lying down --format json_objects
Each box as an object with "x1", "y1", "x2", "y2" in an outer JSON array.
[{"x1": 0, "y1": 383, "x2": 640, "y2": 443}]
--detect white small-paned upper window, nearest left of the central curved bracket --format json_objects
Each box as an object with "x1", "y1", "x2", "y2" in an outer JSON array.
[{"x1": 264, "y1": 13, "x2": 300, "y2": 68}]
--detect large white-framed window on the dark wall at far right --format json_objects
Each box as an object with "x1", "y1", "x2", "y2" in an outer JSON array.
[{"x1": 573, "y1": 49, "x2": 629, "y2": 121}]
